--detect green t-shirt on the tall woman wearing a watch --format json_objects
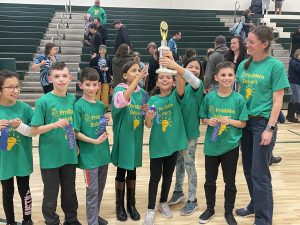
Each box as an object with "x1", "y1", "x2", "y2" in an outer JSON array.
[{"x1": 237, "y1": 56, "x2": 289, "y2": 118}]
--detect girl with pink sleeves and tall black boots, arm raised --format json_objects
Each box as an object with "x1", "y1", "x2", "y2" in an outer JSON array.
[{"x1": 111, "y1": 61, "x2": 148, "y2": 221}]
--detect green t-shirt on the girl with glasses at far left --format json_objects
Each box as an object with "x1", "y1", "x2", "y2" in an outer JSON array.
[{"x1": 0, "y1": 101, "x2": 33, "y2": 180}]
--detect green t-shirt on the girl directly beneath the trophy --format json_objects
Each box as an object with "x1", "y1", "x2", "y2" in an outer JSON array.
[{"x1": 148, "y1": 90, "x2": 187, "y2": 159}]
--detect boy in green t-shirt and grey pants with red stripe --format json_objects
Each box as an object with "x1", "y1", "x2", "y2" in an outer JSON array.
[{"x1": 74, "y1": 68, "x2": 110, "y2": 225}]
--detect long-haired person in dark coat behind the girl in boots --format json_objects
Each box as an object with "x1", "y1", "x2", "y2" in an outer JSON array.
[{"x1": 112, "y1": 44, "x2": 132, "y2": 87}]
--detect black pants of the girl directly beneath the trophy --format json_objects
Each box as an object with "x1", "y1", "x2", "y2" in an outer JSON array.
[{"x1": 148, "y1": 152, "x2": 177, "y2": 209}]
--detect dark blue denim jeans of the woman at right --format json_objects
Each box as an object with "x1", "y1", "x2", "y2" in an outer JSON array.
[{"x1": 241, "y1": 117, "x2": 276, "y2": 225}]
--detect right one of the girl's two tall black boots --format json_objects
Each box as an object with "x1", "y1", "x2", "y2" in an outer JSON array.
[{"x1": 126, "y1": 180, "x2": 141, "y2": 221}]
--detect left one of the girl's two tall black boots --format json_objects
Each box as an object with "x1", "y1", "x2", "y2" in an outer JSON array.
[{"x1": 115, "y1": 180, "x2": 127, "y2": 221}]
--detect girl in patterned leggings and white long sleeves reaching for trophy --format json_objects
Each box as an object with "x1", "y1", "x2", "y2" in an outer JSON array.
[{"x1": 163, "y1": 55, "x2": 203, "y2": 216}]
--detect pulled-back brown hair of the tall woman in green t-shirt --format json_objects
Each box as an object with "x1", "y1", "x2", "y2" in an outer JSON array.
[{"x1": 244, "y1": 26, "x2": 274, "y2": 70}]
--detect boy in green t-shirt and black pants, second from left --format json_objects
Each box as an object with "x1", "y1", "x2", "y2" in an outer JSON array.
[{"x1": 31, "y1": 62, "x2": 81, "y2": 225}]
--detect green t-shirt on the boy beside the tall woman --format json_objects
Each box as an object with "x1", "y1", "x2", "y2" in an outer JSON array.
[{"x1": 200, "y1": 90, "x2": 248, "y2": 156}]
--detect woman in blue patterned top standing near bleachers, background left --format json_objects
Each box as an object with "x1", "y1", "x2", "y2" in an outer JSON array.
[{"x1": 31, "y1": 43, "x2": 60, "y2": 94}]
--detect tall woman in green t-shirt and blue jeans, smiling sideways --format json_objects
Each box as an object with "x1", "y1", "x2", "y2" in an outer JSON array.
[{"x1": 236, "y1": 26, "x2": 289, "y2": 225}]
